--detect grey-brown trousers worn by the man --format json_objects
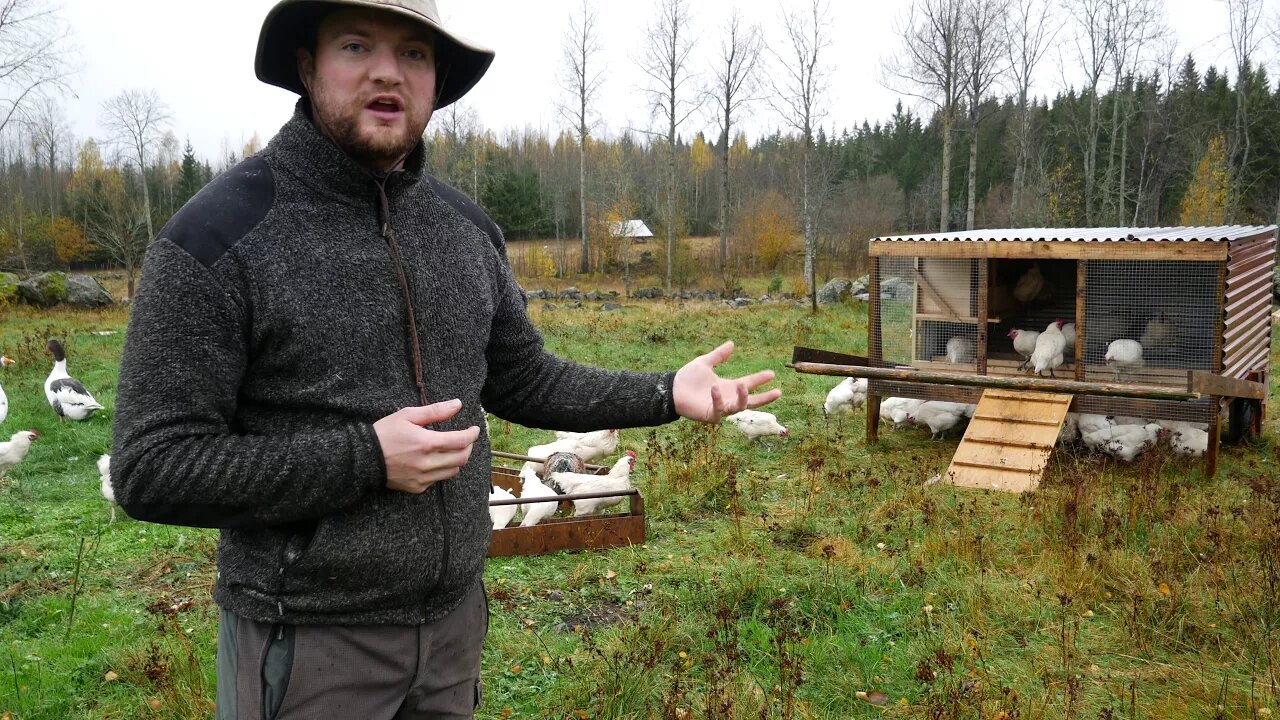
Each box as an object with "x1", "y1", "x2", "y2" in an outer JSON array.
[{"x1": 218, "y1": 583, "x2": 489, "y2": 720}]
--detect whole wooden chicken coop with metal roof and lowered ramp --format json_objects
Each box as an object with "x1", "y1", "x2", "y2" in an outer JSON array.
[{"x1": 794, "y1": 225, "x2": 1276, "y2": 489}]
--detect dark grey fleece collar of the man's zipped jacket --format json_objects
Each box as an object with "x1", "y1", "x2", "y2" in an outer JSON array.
[{"x1": 266, "y1": 97, "x2": 425, "y2": 208}]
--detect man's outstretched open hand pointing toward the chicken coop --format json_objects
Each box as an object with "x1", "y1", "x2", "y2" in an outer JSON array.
[{"x1": 672, "y1": 341, "x2": 782, "y2": 423}]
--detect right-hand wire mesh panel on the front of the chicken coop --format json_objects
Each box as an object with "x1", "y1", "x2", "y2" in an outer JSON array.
[{"x1": 1084, "y1": 260, "x2": 1222, "y2": 386}]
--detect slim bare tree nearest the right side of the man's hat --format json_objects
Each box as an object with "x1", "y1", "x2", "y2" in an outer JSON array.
[{"x1": 561, "y1": 0, "x2": 604, "y2": 273}]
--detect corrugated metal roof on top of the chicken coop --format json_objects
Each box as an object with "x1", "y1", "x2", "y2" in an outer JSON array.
[{"x1": 872, "y1": 225, "x2": 1276, "y2": 242}]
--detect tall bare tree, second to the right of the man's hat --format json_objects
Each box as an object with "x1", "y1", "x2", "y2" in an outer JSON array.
[{"x1": 640, "y1": 0, "x2": 698, "y2": 296}]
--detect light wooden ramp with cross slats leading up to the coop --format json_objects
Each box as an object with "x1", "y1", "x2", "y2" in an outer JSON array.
[{"x1": 943, "y1": 389, "x2": 1071, "y2": 492}]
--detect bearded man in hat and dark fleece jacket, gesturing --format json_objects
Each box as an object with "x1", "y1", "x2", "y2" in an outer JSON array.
[{"x1": 113, "y1": 0, "x2": 781, "y2": 720}]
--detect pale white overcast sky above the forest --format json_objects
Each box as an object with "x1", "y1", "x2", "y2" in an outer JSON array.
[{"x1": 61, "y1": 0, "x2": 1249, "y2": 164}]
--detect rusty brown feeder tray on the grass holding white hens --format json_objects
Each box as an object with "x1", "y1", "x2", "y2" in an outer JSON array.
[{"x1": 489, "y1": 465, "x2": 645, "y2": 557}]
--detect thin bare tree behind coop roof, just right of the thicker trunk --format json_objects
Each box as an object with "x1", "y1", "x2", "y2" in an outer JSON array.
[{"x1": 961, "y1": 0, "x2": 1009, "y2": 231}]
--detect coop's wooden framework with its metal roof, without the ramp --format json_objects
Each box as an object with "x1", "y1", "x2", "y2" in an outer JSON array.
[{"x1": 792, "y1": 225, "x2": 1276, "y2": 484}]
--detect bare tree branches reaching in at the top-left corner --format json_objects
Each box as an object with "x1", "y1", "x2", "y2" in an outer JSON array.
[{"x1": 0, "y1": 0, "x2": 70, "y2": 132}]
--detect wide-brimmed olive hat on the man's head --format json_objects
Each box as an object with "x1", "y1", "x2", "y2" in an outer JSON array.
[{"x1": 253, "y1": 0, "x2": 494, "y2": 109}]
